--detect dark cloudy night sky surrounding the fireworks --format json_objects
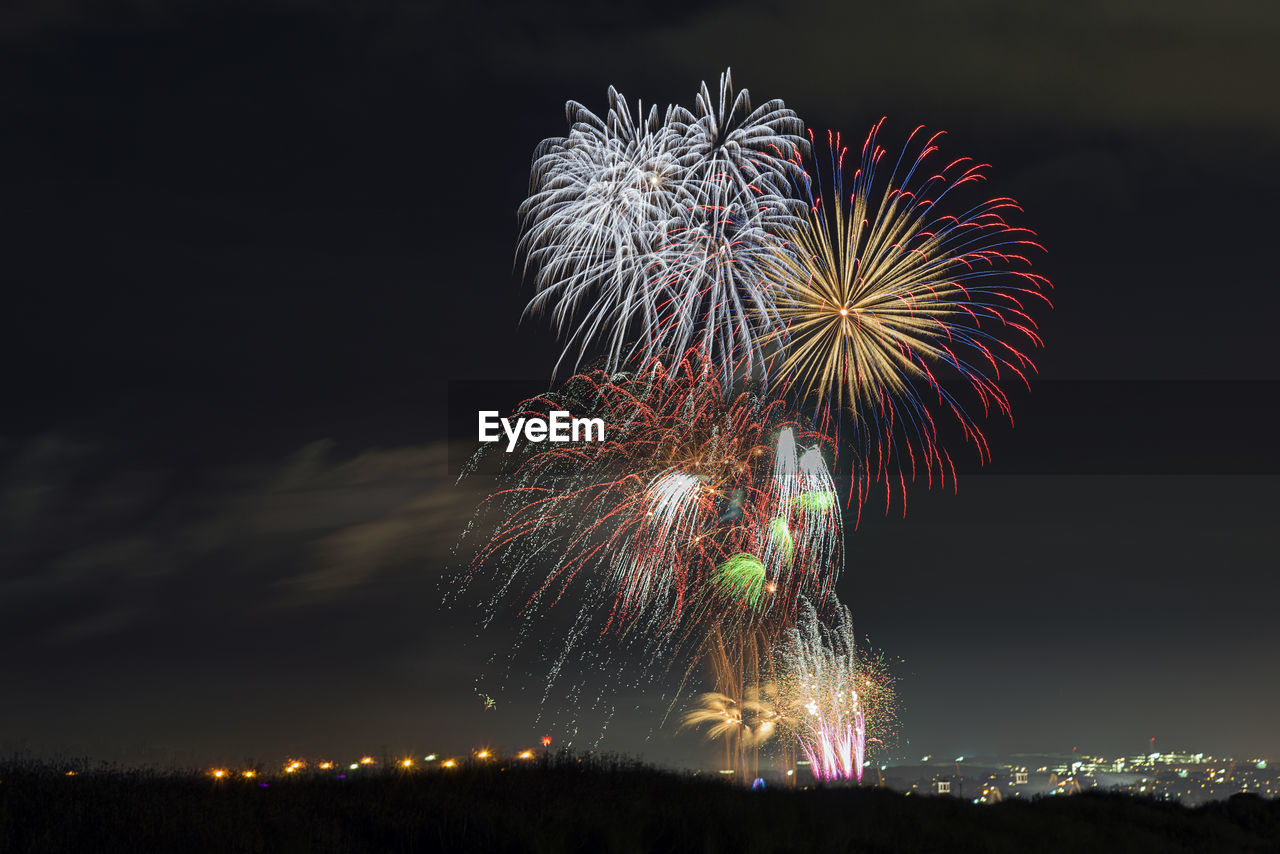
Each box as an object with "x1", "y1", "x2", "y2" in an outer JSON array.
[{"x1": 0, "y1": 0, "x2": 1280, "y2": 764}]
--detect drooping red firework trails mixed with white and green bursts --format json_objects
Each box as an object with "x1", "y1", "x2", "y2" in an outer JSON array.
[{"x1": 458, "y1": 352, "x2": 842, "y2": 711}]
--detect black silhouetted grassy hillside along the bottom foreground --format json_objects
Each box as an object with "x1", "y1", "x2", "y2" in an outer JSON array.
[{"x1": 0, "y1": 761, "x2": 1280, "y2": 854}]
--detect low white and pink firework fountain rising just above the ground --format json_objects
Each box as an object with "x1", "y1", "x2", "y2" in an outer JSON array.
[{"x1": 776, "y1": 602, "x2": 895, "y2": 780}]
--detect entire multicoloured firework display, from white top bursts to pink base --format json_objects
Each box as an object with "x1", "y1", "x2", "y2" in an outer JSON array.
[{"x1": 460, "y1": 72, "x2": 1050, "y2": 781}]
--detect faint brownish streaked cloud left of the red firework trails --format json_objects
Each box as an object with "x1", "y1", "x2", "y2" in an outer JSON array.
[{"x1": 0, "y1": 434, "x2": 481, "y2": 644}]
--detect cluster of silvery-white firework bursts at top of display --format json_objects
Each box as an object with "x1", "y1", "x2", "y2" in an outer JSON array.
[{"x1": 520, "y1": 72, "x2": 806, "y2": 383}]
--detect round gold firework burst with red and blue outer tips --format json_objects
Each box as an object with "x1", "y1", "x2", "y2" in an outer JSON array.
[{"x1": 764, "y1": 124, "x2": 1048, "y2": 514}]
